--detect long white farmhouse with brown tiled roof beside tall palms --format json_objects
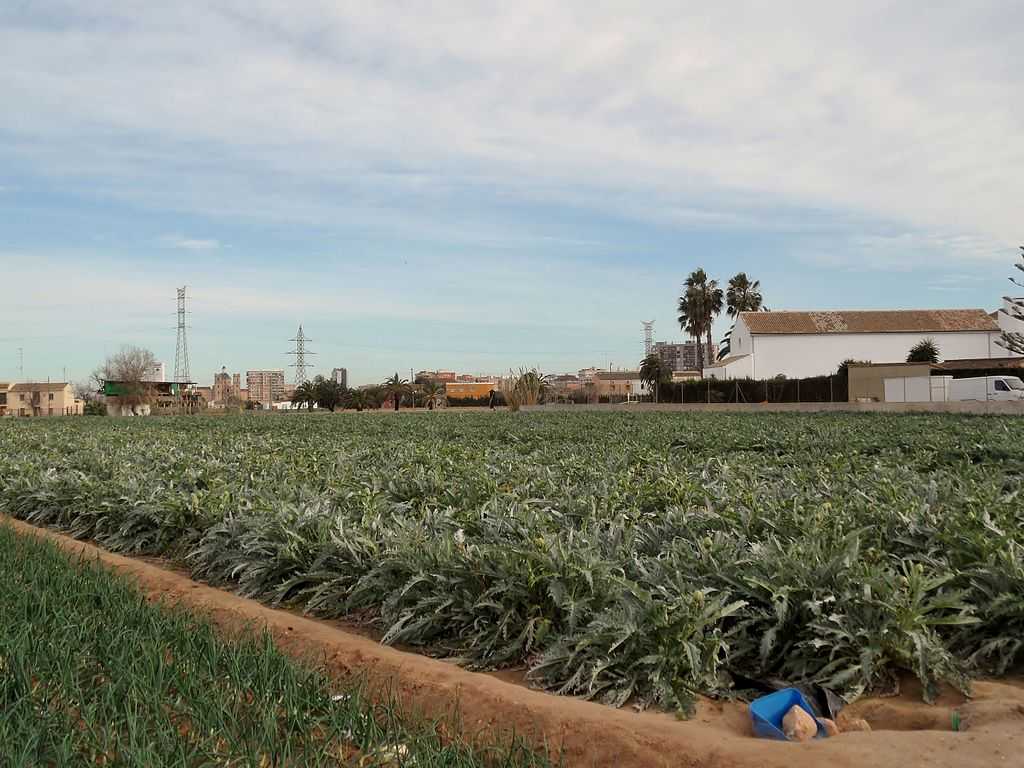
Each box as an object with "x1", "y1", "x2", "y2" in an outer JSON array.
[{"x1": 705, "y1": 309, "x2": 1007, "y2": 379}]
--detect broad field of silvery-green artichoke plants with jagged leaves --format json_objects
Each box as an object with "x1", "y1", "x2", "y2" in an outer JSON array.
[{"x1": 0, "y1": 412, "x2": 1024, "y2": 713}]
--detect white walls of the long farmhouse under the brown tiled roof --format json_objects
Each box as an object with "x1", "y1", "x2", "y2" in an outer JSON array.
[{"x1": 729, "y1": 317, "x2": 1006, "y2": 379}]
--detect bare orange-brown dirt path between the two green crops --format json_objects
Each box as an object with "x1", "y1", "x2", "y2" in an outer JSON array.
[{"x1": 0, "y1": 515, "x2": 1024, "y2": 768}]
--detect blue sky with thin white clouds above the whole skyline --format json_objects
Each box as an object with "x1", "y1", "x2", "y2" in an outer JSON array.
[{"x1": 0, "y1": 0, "x2": 1024, "y2": 384}]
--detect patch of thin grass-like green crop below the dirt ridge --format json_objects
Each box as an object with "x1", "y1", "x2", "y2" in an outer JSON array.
[{"x1": 0, "y1": 526, "x2": 542, "y2": 768}]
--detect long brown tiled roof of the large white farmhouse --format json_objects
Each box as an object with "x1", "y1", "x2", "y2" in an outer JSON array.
[{"x1": 739, "y1": 309, "x2": 999, "y2": 334}]
